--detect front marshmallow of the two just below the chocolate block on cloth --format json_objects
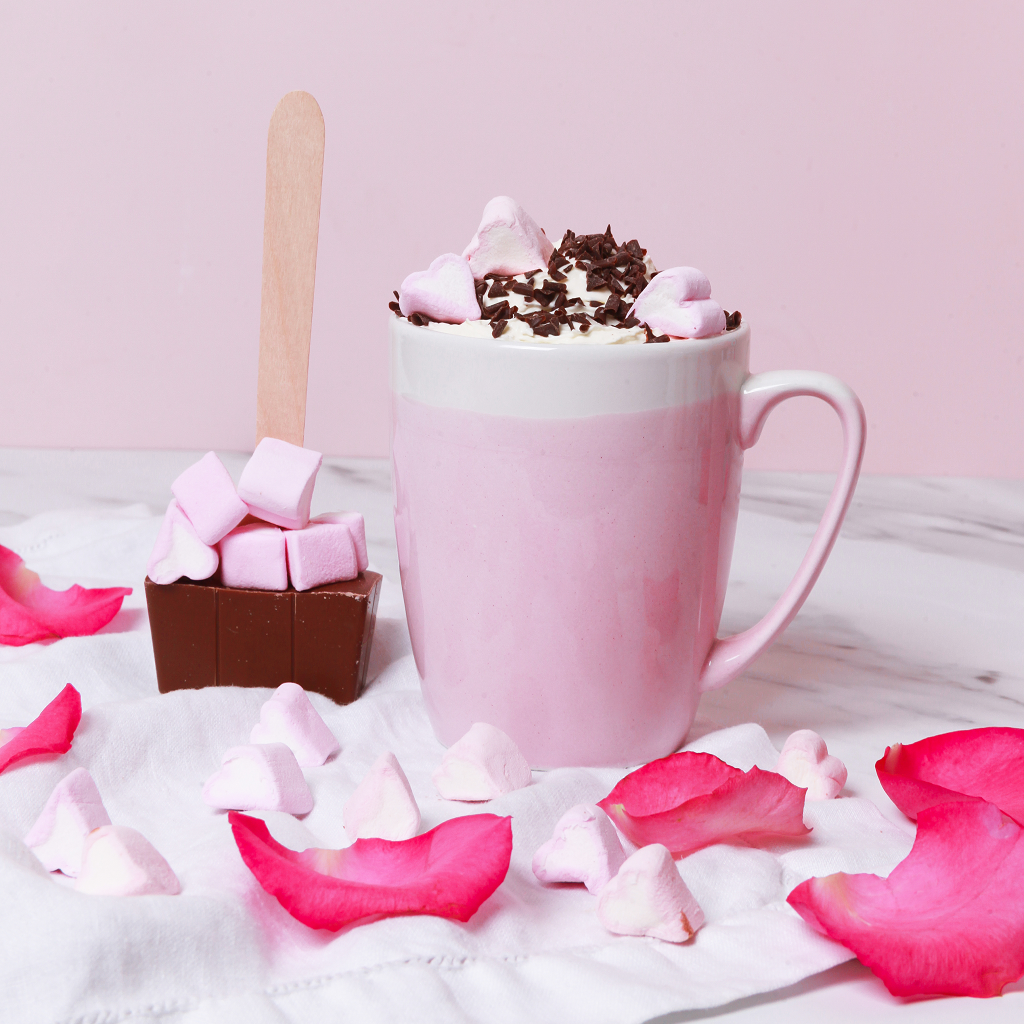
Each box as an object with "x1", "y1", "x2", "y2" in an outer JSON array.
[{"x1": 203, "y1": 743, "x2": 313, "y2": 814}]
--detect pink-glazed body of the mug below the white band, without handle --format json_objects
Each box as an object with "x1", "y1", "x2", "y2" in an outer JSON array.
[{"x1": 393, "y1": 394, "x2": 741, "y2": 767}]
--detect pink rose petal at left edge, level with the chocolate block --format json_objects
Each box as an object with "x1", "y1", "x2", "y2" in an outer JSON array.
[{"x1": 0, "y1": 545, "x2": 131, "y2": 647}]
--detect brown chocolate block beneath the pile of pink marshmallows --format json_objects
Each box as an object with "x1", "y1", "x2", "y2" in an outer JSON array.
[{"x1": 145, "y1": 572, "x2": 381, "y2": 703}]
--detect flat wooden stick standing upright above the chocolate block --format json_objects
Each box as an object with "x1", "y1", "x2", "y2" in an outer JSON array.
[{"x1": 256, "y1": 92, "x2": 324, "y2": 446}]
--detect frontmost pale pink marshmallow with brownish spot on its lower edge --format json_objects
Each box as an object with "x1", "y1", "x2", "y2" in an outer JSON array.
[{"x1": 597, "y1": 843, "x2": 705, "y2": 942}]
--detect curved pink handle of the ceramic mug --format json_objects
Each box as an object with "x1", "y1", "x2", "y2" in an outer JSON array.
[{"x1": 698, "y1": 370, "x2": 866, "y2": 692}]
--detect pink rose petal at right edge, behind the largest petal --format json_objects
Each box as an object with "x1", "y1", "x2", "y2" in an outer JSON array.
[{"x1": 874, "y1": 728, "x2": 1024, "y2": 824}]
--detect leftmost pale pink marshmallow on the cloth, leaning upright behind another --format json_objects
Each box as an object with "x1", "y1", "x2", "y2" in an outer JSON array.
[{"x1": 25, "y1": 768, "x2": 111, "y2": 878}]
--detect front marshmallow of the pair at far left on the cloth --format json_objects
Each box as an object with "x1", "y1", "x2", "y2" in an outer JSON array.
[{"x1": 75, "y1": 825, "x2": 181, "y2": 896}]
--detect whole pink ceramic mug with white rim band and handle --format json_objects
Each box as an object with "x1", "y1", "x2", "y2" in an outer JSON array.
[{"x1": 391, "y1": 318, "x2": 864, "y2": 767}]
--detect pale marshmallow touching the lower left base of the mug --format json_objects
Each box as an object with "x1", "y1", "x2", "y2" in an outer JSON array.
[{"x1": 433, "y1": 722, "x2": 532, "y2": 801}]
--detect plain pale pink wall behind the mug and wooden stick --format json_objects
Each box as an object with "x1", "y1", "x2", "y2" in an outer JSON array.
[{"x1": 0, "y1": 0, "x2": 1024, "y2": 477}]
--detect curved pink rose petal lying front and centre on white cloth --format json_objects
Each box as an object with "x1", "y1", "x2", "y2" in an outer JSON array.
[{"x1": 227, "y1": 811, "x2": 512, "y2": 932}]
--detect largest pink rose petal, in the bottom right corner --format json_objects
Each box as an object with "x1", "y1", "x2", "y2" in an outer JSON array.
[{"x1": 788, "y1": 802, "x2": 1024, "y2": 996}]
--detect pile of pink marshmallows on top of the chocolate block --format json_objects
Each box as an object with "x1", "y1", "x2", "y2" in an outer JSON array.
[{"x1": 146, "y1": 437, "x2": 368, "y2": 590}]
